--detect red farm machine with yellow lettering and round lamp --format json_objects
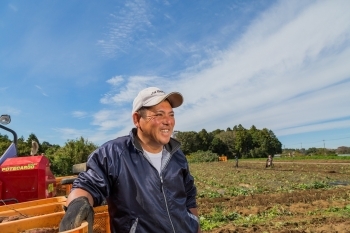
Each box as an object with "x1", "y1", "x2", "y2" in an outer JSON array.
[{"x1": 0, "y1": 115, "x2": 56, "y2": 205}]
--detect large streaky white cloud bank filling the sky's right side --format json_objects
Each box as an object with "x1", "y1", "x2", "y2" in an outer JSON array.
[{"x1": 170, "y1": 1, "x2": 350, "y2": 135}]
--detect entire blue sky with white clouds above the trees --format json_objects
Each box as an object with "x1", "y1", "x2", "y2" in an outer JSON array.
[{"x1": 0, "y1": 0, "x2": 350, "y2": 148}]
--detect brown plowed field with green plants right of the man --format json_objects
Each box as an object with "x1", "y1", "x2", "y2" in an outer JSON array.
[{"x1": 190, "y1": 159, "x2": 350, "y2": 233}]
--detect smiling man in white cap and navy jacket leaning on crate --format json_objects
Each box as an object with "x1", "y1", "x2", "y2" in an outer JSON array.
[{"x1": 60, "y1": 87, "x2": 200, "y2": 233}]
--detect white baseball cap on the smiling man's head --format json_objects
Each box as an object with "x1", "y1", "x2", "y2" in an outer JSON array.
[{"x1": 132, "y1": 87, "x2": 183, "y2": 114}]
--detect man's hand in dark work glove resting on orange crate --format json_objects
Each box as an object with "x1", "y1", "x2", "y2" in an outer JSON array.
[{"x1": 59, "y1": 196, "x2": 94, "y2": 233}]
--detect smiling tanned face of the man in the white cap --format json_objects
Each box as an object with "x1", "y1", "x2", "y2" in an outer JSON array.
[{"x1": 138, "y1": 101, "x2": 175, "y2": 152}]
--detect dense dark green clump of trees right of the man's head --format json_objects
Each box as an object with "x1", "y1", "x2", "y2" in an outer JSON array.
[{"x1": 174, "y1": 124, "x2": 282, "y2": 158}]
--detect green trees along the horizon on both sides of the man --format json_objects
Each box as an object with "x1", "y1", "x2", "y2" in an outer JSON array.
[{"x1": 0, "y1": 125, "x2": 282, "y2": 176}]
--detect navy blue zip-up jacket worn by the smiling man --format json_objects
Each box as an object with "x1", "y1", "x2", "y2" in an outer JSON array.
[{"x1": 73, "y1": 129, "x2": 198, "y2": 233}]
